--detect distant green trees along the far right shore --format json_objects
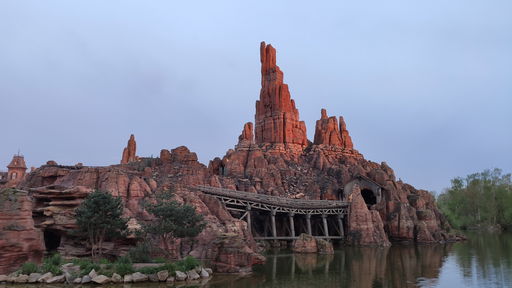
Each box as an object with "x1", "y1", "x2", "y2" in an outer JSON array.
[{"x1": 437, "y1": 169, "x2": 512, "y2": 229}]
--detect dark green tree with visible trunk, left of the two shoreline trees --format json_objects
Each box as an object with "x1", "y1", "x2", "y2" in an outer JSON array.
[{"x1": 75, "y1": 190, "x2": 127, "y2": 258}]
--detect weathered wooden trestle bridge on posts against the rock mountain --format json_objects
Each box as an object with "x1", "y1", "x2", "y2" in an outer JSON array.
[{"x1": 194, "y1": 186, "x2": 349, "y2": 240}]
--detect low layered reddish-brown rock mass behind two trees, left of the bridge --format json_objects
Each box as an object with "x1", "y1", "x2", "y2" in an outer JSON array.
[{"x1": 7, "y1": 146, "x2": 264, "y2": 272}]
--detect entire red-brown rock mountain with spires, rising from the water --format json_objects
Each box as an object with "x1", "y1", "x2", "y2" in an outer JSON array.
[{"x1": 0, "y1": 43, "x2": 457, "y2": 274}]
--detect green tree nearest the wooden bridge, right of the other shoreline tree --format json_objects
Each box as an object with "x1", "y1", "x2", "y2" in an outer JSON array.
[{"x1": 144, "y1": 191, "x2": 206, "y2": 252}]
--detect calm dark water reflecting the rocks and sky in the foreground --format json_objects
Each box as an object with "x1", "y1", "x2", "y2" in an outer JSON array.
[{"x1": 6, "y1": 233, "x2": 512, "y2": 288}]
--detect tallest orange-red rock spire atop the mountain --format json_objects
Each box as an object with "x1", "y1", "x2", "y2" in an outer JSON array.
[{"x1": 255, "y1": 42, "x2": 308, "y2": 146}]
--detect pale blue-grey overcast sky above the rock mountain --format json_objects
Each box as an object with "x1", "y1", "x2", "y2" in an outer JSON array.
[{"x1": 0, "y1": 0, "x2": 512, "y2": 192}]
